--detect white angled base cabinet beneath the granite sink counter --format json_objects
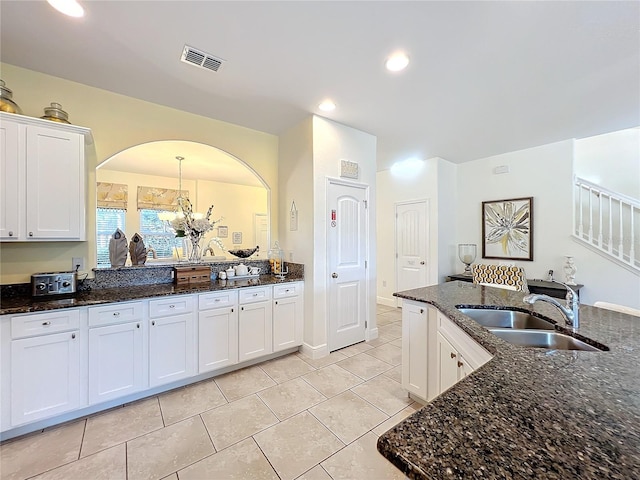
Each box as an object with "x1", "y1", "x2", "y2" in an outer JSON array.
[{"x1": 402, "y1": 300, "x2": 491, "y2": 401}]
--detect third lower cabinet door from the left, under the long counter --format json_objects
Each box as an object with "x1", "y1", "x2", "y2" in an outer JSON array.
[{"x1": 149, "y1": 313, "x2": 195, "y2": 387}]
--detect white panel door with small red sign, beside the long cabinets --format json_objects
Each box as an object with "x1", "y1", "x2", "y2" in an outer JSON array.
[{"x1": 327, "y1": 183, "x2": 367, "y2": 351}]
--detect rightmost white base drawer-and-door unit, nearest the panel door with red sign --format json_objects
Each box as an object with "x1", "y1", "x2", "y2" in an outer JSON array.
[{"x1": 273, "y1": 282, "x2": 304, "y2": 352}]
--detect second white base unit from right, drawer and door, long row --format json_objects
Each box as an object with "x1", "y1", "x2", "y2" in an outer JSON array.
[{"x1": 238, "y1": 287, "x2": 273, "y2": 362}]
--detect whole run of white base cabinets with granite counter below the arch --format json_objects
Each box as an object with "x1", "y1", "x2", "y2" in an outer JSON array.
[{"x1": 0, "y1": 260, "x2": 304, "y2": 440}]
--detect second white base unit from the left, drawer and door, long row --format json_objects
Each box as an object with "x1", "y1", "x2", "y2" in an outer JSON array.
[{"x1": 88, "y1": 302, "x2": 147, "y2": 405}]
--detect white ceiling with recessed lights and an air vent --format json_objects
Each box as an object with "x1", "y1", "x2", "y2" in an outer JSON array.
[{"x1": 0, "y1": 0, "x2": 640, "y2": 169}]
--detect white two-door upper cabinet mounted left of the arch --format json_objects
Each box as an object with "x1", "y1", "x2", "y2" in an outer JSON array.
[{"x1": 0, "y1": 113, "x2": 92, "y2": 242}]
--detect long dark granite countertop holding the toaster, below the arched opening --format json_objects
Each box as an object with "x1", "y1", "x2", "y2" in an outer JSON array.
[{"x1": 0, "y1": 274, "x2": 303, "y2": 315}]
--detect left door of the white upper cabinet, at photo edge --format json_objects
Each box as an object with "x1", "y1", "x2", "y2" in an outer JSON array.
[{"x1": 0, "y1": 121, "x2": 24, "y2": 240}]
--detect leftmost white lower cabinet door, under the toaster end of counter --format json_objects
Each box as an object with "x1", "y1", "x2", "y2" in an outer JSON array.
[{"x1": 11, "y1": 331, "x2": 80, "y2": 426}]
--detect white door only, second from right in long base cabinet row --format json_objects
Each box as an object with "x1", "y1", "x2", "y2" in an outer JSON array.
[{"x1": 238, "y1": 301, "x2": 273, "y2": 362}]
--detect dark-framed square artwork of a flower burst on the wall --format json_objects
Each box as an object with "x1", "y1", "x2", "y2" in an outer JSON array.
[{"x1": 482, "y1": 197, "x2": 533, "y2": 261}]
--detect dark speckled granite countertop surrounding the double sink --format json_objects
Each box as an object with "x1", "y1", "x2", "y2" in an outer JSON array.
[{"x1": 378, "y1": 282, "x2": 640, "y2": 480}]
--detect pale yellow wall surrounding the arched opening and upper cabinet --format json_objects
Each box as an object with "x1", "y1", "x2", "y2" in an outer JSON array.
[{"x1": 0, "y1": 63, "x2": 278, "y2": 284}]
